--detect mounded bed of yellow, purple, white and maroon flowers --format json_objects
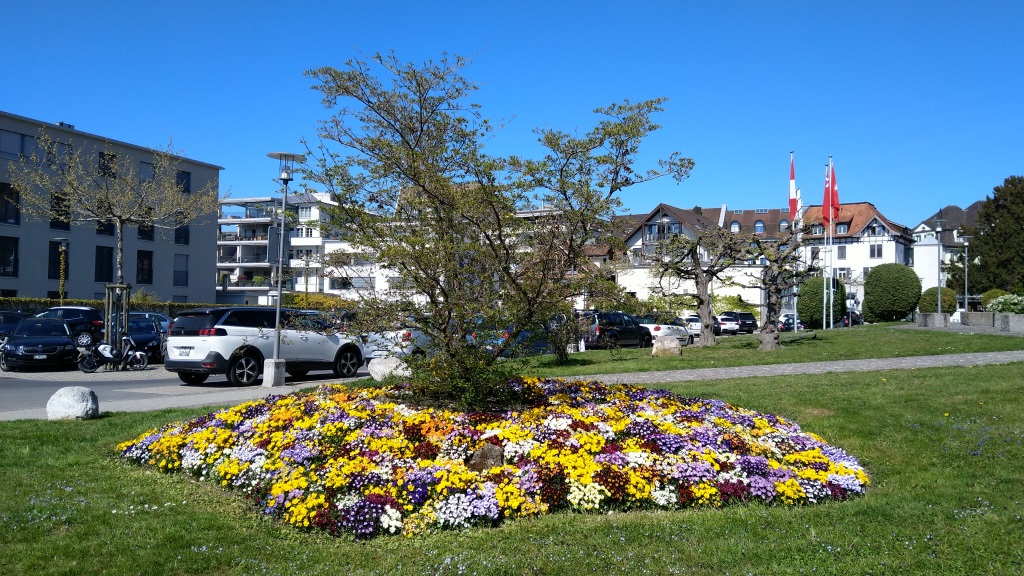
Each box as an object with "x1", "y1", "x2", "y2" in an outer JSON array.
[{"x1": 118, "y1": 379, "x2": 869, "y2": 538}]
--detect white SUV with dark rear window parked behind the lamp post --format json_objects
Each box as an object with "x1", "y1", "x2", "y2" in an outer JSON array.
[{"x1": 164, "y1": 307, "x2": 362, "y2": 385}]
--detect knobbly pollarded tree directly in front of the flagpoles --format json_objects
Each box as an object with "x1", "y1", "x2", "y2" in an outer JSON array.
[{"x1": 751, "y1": 227, "x2": 814, "y2": 351}]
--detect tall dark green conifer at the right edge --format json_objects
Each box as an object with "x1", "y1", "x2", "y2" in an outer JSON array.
[{"x1": 961, "y1": 176, "x2": 1024, "y2": 294}]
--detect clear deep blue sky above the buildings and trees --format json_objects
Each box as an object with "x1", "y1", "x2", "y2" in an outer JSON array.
[{"x1": 0, "y1": 0, "x2": 1024, "y2": 227}]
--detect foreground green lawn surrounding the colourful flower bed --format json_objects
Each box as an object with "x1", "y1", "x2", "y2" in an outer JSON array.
[{"x1": 0, "y1": 352, "x2": 1024, "y2": 575}]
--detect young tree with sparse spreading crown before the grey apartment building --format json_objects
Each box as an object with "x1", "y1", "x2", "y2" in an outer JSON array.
[{"x1": 9, "y1": 132, "x2": 219, "y2": 284}]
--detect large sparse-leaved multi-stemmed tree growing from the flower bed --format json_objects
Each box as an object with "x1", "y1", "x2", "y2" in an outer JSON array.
[{"x1": 306, "y1": 54, "x2": 692, "y2": 405}]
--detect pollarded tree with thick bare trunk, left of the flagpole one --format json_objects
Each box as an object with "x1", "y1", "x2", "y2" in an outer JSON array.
[{"x1": 650, "y1": 227, "x2": 754, "y2": 346}]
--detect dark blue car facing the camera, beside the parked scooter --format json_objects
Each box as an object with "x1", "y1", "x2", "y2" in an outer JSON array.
[{"x1": 0, "y1": 318, "x2": 78, "y2": 372}]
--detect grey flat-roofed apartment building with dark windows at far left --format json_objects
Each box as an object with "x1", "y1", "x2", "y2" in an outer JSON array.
[{"x1": 0, "y1": 112, "x2": 222, "y2": 303}]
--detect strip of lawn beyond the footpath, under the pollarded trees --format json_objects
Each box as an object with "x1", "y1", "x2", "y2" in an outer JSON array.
[{"x1": 524, "y1": 324, "x2": 1024, "y2": 377}]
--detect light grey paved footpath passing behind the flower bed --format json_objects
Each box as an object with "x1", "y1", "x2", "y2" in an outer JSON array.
[{"x1": 0, "y1": 344, "x2": 1024, "y2": 420}]
